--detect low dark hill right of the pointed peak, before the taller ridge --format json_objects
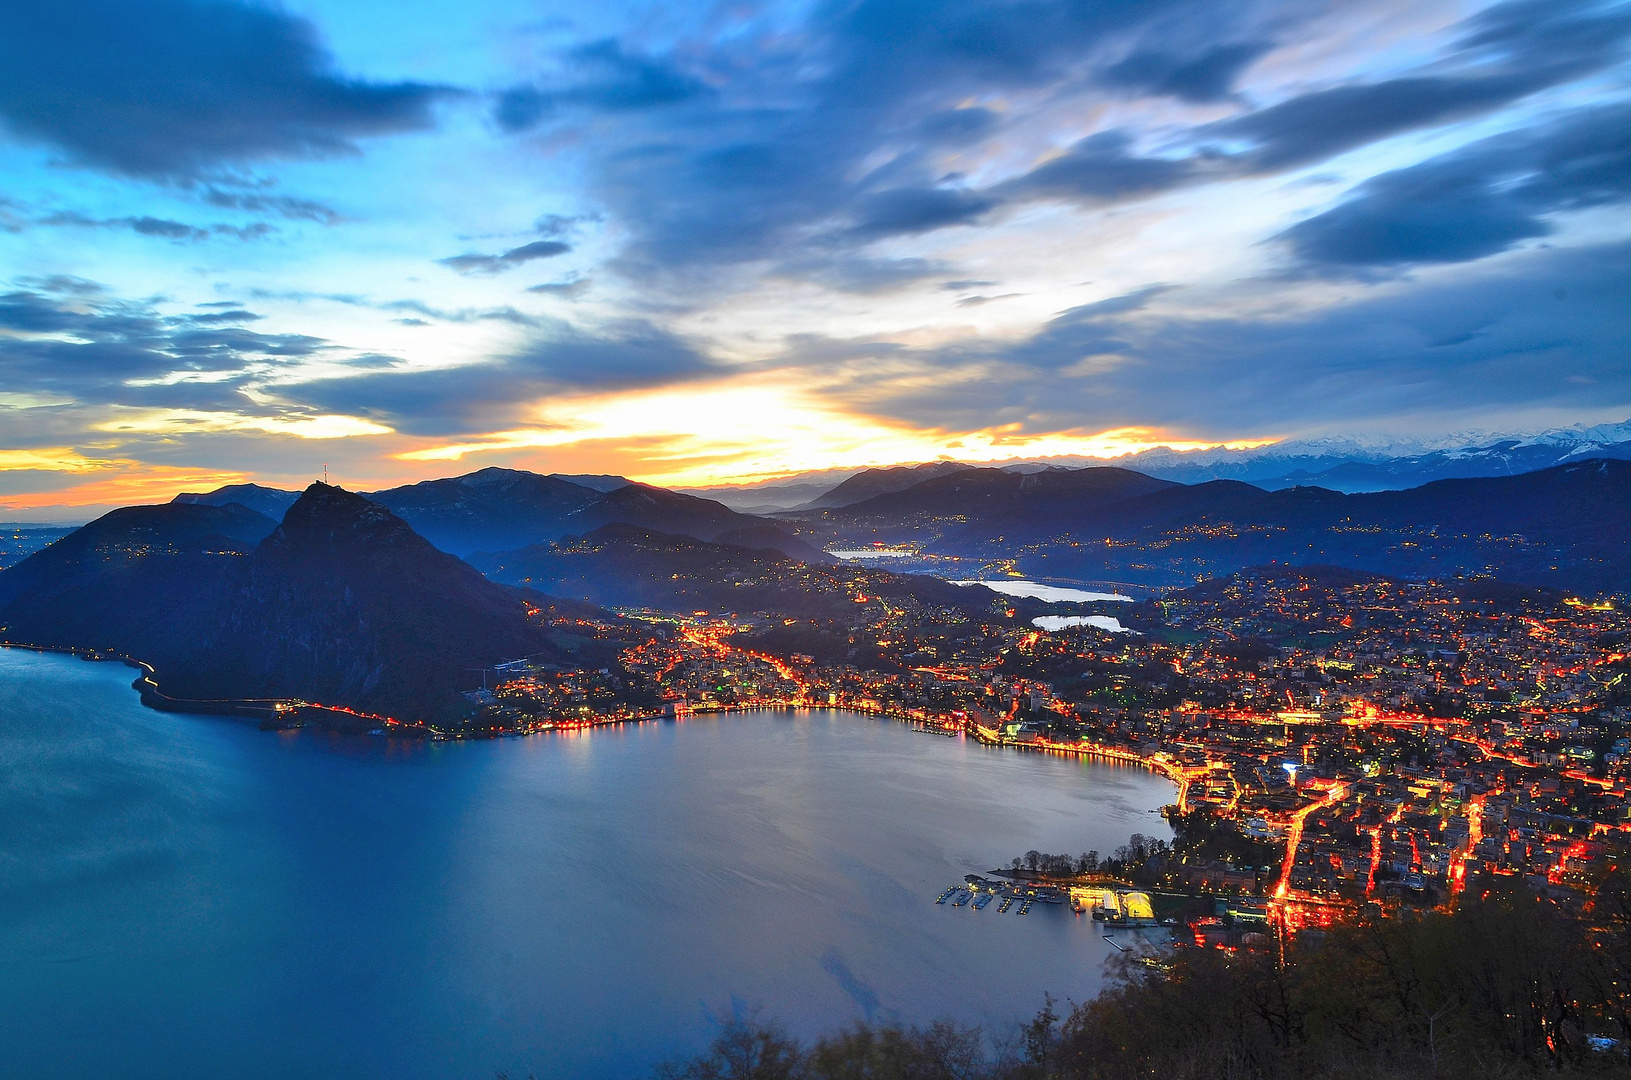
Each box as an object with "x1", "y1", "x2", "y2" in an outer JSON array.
[{"x1": 475, "y1": 524, "x2": 997, "y2": 620}]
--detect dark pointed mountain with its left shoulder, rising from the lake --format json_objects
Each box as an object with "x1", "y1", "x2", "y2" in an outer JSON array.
[{"x1": 0, "y1": 483, "x2": 583, "y2": 718}]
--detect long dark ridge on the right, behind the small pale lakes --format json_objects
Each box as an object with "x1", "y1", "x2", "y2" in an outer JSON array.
[{"x1": 828, "y1": 460, "x2": 1631, "y2": 589}]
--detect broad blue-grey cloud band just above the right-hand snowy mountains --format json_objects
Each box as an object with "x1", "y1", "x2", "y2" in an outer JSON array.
[{"x1": 822, "y1": 243, "x2": 1631, "y2": 437}]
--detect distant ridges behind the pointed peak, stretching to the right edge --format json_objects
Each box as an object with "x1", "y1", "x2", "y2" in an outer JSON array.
[{"x1": 143, "y1": 450, "x2": 1631, "y2": 591}]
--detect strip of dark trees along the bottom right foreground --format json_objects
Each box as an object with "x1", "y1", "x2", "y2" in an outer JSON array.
[{"x1": 659, "y1": 871, "x2": 1631, "y2": 1080}]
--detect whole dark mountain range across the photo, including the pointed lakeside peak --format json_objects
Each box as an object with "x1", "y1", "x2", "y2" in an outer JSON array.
[{"x1": 0, "y1": 443, "x2": 1631, "y2": 718}]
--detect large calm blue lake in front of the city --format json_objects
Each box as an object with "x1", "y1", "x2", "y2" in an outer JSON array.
[{"x1": 0, "y1": 649, "x2": 1171, "y2": 1080}]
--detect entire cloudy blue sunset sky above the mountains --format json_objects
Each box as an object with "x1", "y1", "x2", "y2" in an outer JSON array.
[{"x1": 0, "y1": 0, "x2": 1631, "y2": 517}]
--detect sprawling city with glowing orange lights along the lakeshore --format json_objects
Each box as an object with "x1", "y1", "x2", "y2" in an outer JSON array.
[{"x1": 445, "y1": 568, "x2": 1631, "y2": 946}]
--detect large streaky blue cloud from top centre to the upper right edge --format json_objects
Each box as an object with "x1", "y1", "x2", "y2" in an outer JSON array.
[{"x1": 492, "y1": 0, "x2": 1631, "y2": 287}]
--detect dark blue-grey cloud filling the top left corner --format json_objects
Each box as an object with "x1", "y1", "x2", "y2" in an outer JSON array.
[{"x1": 0, "y1": 0, "x2": 447, "y2": 179}]
